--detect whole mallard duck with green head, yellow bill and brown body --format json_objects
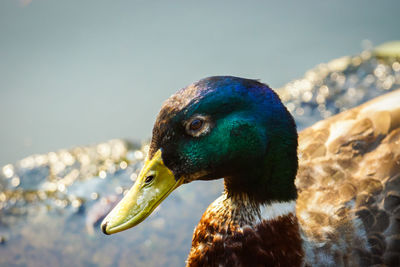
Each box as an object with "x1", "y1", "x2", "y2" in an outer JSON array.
[{"x1": 101, "y1": 76, "x2": 400, "y2": 266}]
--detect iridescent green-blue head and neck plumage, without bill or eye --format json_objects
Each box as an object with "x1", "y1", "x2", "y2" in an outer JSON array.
[{"x1": 149, "y1": 77, "x2": 297, "y2": 202}]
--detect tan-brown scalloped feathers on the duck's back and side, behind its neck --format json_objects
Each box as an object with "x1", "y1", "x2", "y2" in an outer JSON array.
[{"x1": 296, "y1": 90, "x2": 400, "y2": 266}]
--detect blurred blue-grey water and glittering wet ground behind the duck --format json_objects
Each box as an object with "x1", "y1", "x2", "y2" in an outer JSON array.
[{"x1": 0, "y1": 0, "x2": 400, "y2": 266}]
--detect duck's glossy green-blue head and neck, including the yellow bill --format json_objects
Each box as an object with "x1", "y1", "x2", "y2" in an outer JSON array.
[{"x1": 101, "y1": 76, "x2": 298, "y2": 234}]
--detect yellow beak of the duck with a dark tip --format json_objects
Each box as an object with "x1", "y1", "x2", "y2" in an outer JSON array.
[{"x1": 101, "y1": 150, "x2": 183, "y2": 235}]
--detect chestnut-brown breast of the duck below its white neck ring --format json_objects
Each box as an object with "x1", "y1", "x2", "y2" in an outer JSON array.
[{"x1": 187, "y1": 198, "x2": 304, "y2": 267}]
